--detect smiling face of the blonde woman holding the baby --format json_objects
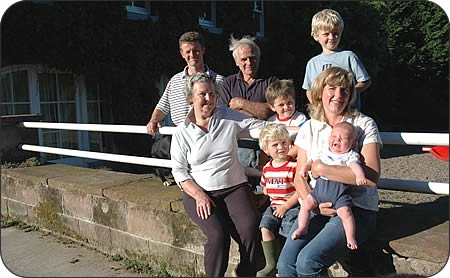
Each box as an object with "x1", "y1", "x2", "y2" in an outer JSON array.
[{"x1": 322, "y1": 85, "x2": 350, "y2": 115}]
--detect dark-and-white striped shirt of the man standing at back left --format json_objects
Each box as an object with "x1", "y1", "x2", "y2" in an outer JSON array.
[{"x1": 155, "y1": 65, "x2": 224, "y2": 126}]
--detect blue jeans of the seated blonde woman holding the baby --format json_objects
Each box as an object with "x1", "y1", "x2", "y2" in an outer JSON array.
[{"x1": 278, "y1": 207, "x2": 376, "y2": 277}]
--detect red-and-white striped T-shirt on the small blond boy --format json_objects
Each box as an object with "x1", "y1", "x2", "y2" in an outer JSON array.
[{"x1": 260, "y1": 157, "x2": 297, "y2": 206}]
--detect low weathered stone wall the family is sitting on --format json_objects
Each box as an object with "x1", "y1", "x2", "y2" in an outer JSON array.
[{"x1": 1, "y1": 165, "x2": 448, "y2": 277}]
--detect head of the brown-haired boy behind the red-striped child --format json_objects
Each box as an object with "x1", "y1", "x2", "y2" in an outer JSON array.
[{"x1": 266, "y1": 79, "x2": 295, "y2": 119}]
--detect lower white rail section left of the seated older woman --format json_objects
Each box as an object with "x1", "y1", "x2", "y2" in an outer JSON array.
[{"x1": 19, "y1": 144, "x2": 172, "y2": 168}]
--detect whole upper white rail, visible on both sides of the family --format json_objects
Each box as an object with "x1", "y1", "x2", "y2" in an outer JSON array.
[{"x1": 22, "y1": 122, "x2": 449, "y2": 146}]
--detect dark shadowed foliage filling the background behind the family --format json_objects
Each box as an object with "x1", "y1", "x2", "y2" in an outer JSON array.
[{"x1": 1, "y1": 0, "x2": 448, "y2": 134}]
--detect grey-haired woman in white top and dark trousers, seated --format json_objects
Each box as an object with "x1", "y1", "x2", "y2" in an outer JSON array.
[{"x1": 171, "y1": 73, "x2": 266, "y2": 277}]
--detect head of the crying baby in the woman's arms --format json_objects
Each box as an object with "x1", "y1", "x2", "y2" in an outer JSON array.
[{"x1": 328, "y1": 122, "x2": 356, "y2": 154}]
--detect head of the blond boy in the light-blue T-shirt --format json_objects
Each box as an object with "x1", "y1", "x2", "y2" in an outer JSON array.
[{"x1": 311, "y1": 9, "x2": 344, "y2": 51}]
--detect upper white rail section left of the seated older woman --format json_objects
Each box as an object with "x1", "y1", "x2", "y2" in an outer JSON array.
[{"x1": 22, "y1": 122, "x2": 175, "y2": 135}]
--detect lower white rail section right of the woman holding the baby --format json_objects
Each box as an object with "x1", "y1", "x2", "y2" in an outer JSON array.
[{"x1": 378, "y1": 179, "x2": 449, "y2": 195}]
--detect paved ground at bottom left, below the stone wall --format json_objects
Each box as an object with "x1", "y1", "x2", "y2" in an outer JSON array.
[{"x1": 1, "y1": 227, "x2": 146, "y2": 277}]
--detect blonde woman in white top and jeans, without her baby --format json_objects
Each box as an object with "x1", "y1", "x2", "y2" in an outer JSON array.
[{"x1": 278, "y1": 67, "x2": 382, "y2": 277}]
